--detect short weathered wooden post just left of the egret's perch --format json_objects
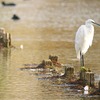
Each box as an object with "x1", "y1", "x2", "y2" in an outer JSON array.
[{"x1": 64, "y1": 66, "x2": 74, "y2": 79}]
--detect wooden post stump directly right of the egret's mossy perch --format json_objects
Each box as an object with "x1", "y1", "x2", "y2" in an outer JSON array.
[{"x1": 85, "y1": 72, "x2": 94, "y2": 86}]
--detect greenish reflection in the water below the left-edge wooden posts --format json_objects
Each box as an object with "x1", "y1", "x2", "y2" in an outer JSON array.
[{"x1": 0, "y1": 48, "x2": 11, "y2": 99}]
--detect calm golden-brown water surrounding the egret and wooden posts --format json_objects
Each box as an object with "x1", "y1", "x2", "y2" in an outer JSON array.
[{"x1": 0, "y1": 0, "x2": 100, "y2": 100}]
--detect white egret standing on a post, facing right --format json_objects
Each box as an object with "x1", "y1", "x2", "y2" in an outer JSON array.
[{"x1": 75, "y1": 19, "x2": 100, "y2": 66}]
